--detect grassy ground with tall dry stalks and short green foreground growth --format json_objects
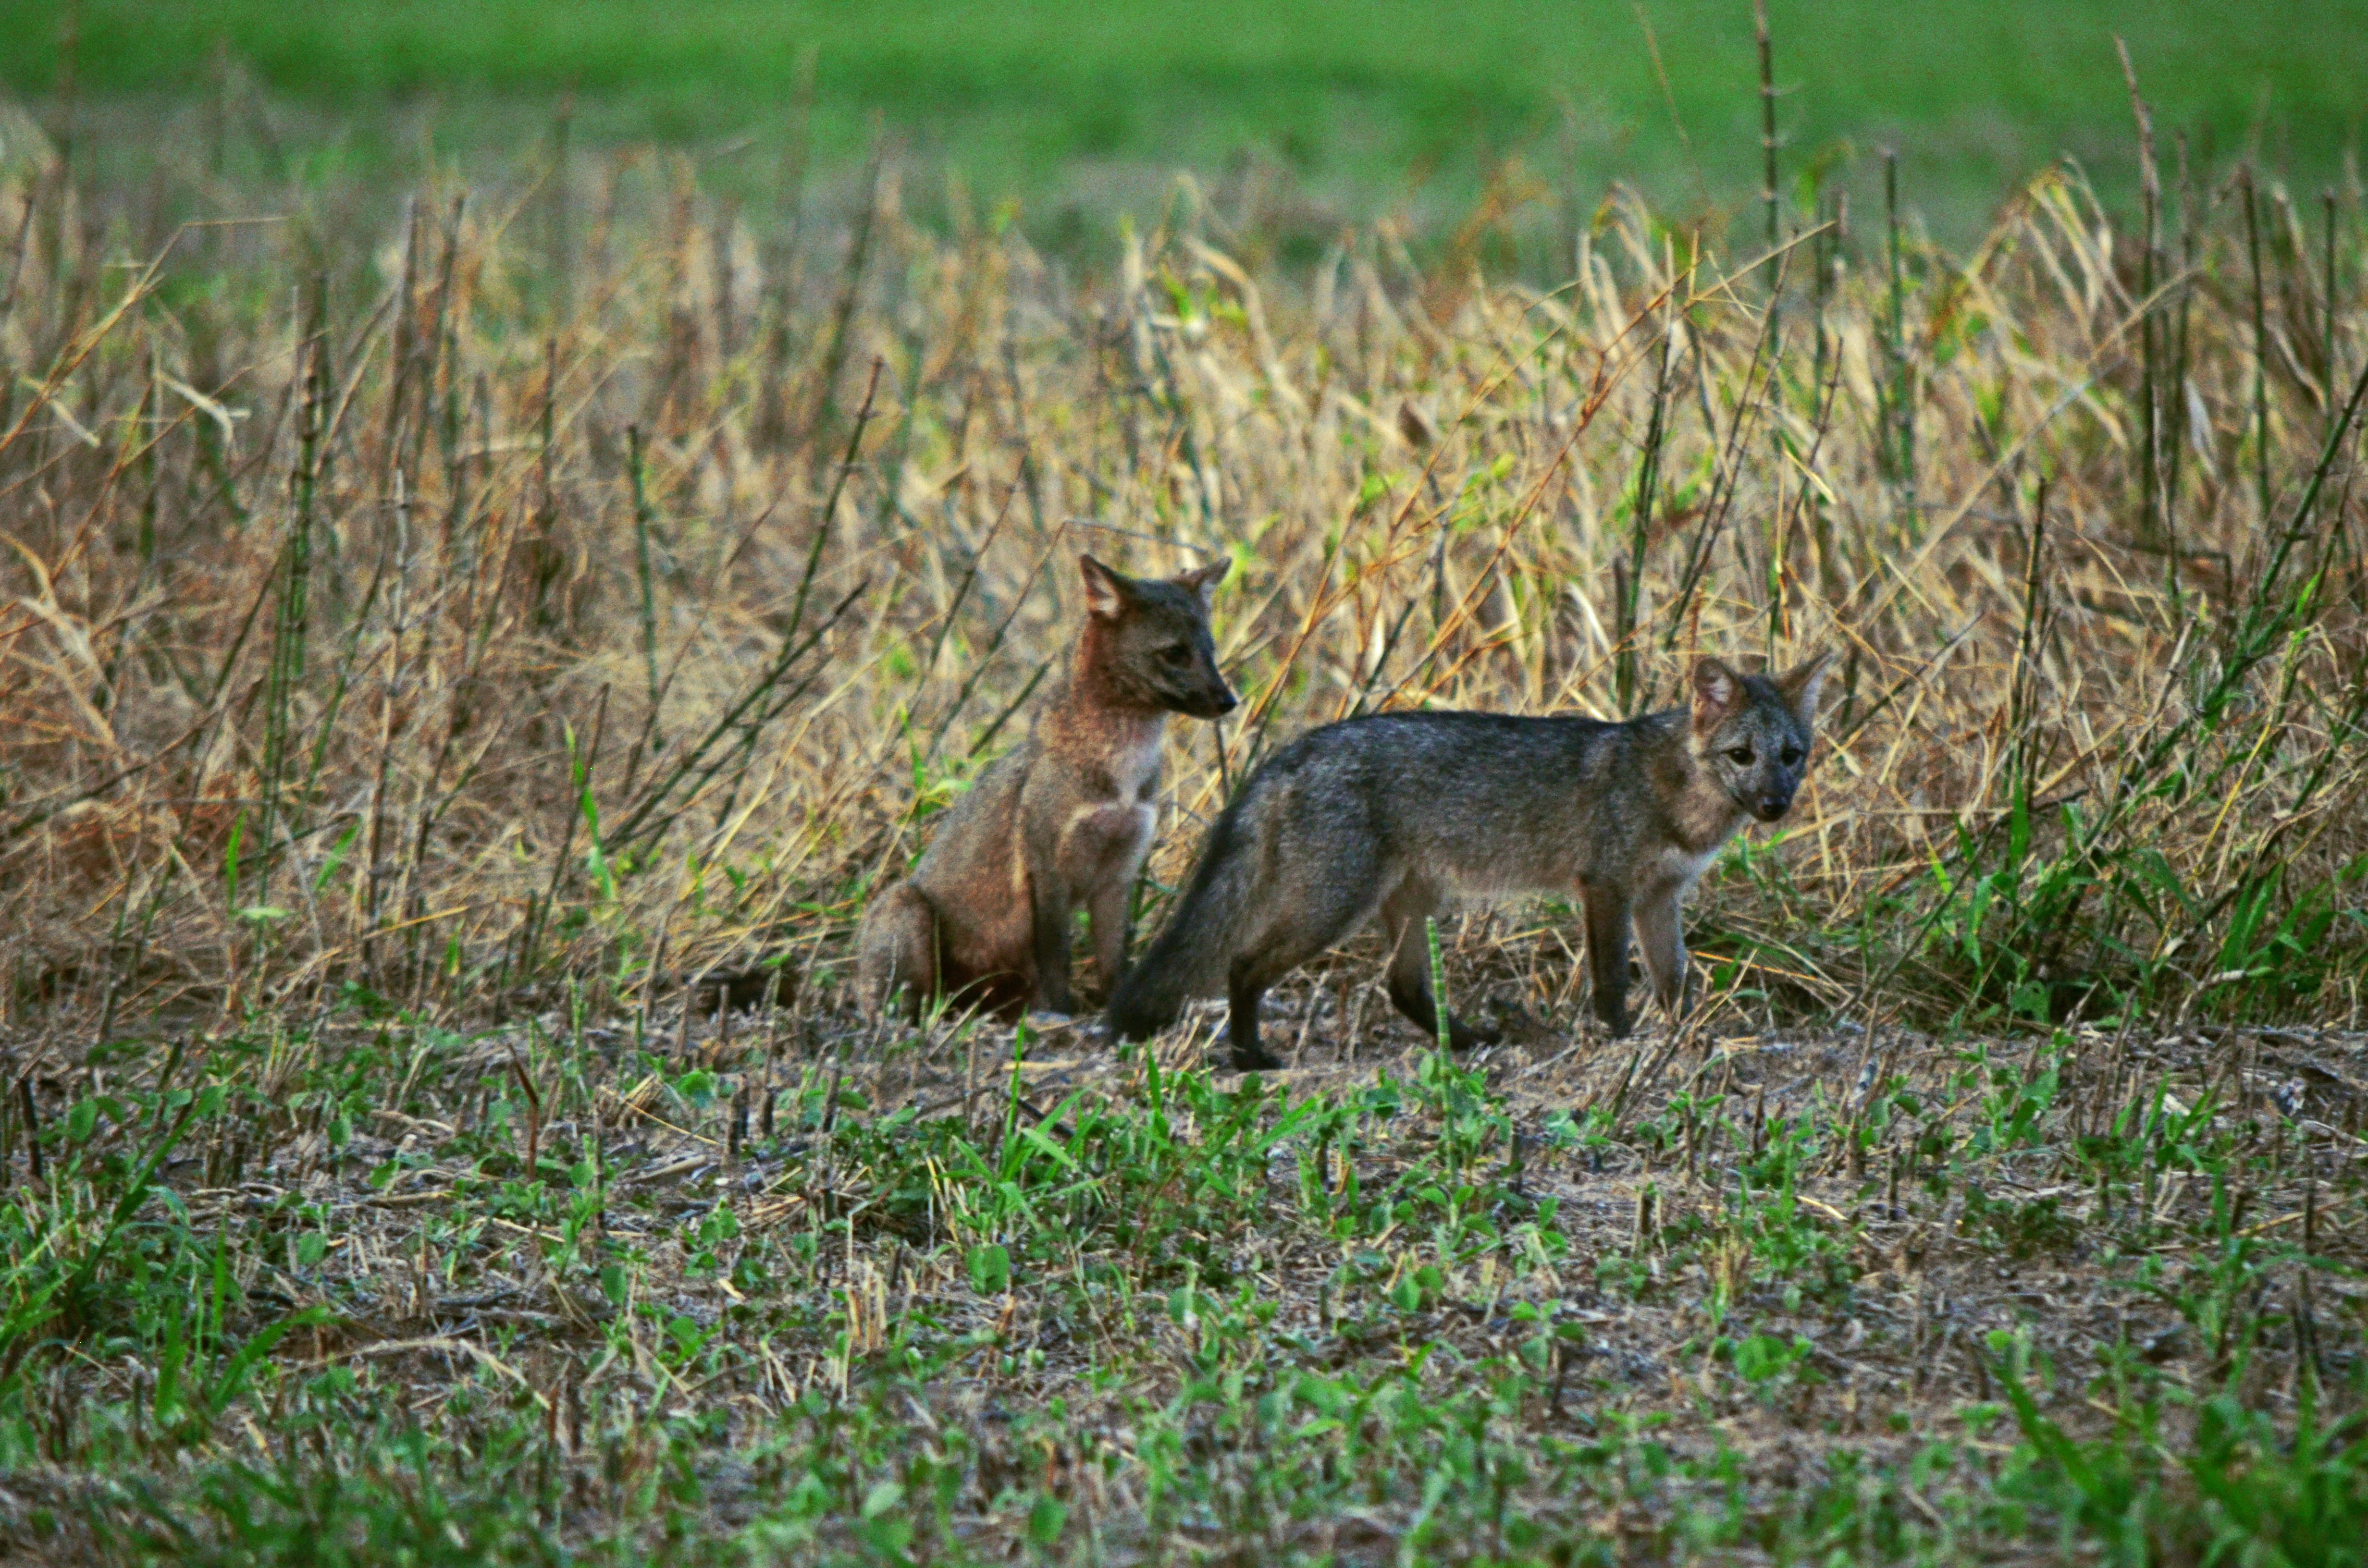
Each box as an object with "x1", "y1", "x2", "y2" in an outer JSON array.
[{"x1": 0, "y1": 64, "x2": 2368, "y2": 1566}]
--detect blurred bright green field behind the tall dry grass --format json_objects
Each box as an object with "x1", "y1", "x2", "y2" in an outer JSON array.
[{"x1": 0, "y1": 0, "x2": 2368, "y2": 247}]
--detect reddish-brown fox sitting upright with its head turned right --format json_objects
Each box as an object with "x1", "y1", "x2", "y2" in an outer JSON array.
[{"x1": 855, "y1": 554, "x2": 1236, "y2": 1016}]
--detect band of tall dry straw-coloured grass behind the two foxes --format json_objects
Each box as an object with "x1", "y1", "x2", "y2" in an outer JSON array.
[{"x1": 0, "y1": 110, "x2": 2368, "y2": 1028}]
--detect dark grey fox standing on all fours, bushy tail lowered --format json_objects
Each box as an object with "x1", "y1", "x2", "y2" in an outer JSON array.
[{"x1": 1110, "y1": 654, "x2": 1825, "y2": 1071}]
